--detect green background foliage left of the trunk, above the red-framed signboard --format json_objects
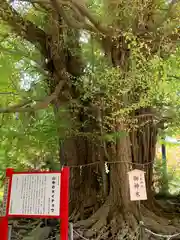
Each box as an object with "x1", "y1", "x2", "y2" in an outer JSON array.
[{"x1": 0, "y1": 23, "x2": 70, "y2": 175}]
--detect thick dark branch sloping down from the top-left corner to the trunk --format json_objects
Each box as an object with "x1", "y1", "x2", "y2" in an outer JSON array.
[{"x1": 0, "y1": 0, "x2": 46, "y2": 52}]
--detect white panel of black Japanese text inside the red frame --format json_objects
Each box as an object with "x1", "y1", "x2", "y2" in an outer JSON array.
[{"x1": 9, "y1": 173, "x2": 61, "y2": 216}]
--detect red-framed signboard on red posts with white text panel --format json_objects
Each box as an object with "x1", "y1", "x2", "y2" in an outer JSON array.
[{"x1": 0, "y1": 167, "x2": 69, "y2": 240}]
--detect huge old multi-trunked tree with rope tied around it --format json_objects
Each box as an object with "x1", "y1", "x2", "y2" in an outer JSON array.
[{"x1": 0, "y1": 0, "x2": 180, "y2": 239}]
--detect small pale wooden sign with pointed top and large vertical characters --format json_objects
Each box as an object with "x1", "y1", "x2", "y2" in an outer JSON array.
[{"x1": 128, "y1": 169, "x2": 147, "y2": 201}]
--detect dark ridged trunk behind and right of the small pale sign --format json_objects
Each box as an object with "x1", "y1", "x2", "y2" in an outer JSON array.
[{"x1": 131, "y1": 108, "x2": 158, "y2": 203}]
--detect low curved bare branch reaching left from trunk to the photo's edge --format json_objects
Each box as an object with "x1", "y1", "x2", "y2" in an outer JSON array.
[{"x1": 0, "y1": 81, "x2": 64, "y2": 113}]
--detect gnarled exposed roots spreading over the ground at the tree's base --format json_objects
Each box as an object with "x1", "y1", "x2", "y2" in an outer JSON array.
[{"x1": 74, "y1": 203, "x2": 180, "y2": 240}]
